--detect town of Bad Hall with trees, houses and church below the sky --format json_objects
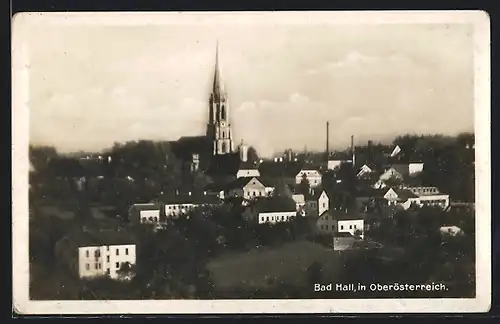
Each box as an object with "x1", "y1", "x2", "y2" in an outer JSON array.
[{"x1": 29, "y1": 45, "x2": 475, "y2": 300}]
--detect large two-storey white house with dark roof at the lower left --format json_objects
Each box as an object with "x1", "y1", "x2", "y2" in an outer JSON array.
[{"x1": 55, "y1": 229, "x2": 137, "y2": 280}]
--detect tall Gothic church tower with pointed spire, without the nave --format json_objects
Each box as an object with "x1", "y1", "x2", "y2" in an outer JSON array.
[{"x1": 207, "y1": 44, "x2": 235, "y2": 155}]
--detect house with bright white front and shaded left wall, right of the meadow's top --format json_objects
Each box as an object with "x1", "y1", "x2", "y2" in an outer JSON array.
[{"x1": 316, "y1": 210, "x2": 365, "y2": 239}]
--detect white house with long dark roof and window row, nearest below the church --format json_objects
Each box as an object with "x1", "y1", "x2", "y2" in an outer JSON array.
[{"x1": 243, "y1": 197, "x2": 297, "y2": 224}]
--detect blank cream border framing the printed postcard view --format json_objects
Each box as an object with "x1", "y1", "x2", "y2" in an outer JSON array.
[{"x1": 12, "y1": 11, "x2": 491, "y2": 315}]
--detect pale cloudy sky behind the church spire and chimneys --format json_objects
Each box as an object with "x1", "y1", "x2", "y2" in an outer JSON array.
[{"x1": 26, "y1": 16, "x2": 474, "y2": 155}]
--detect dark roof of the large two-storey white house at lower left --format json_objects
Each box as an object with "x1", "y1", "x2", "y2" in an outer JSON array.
[{"x1": 65, "y1": 229, "x2": 137, "y2": 247}]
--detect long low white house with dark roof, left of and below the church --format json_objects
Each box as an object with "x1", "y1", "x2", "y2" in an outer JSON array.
[{"x1": 162, "y1": 192, "x2": 222, "y2": 218}]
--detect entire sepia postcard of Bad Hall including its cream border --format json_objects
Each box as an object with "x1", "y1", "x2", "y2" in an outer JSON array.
[{"x1": 12, "y1": 11, "x2": 491, "y2": 314}]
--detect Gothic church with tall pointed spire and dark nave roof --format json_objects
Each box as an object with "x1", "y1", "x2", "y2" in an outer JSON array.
[{"x1": 172, "y1": 45, "x2": 246, "y2": 176}]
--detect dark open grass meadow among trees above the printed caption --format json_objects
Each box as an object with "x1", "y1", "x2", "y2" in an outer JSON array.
[{"x1": 207, "y1": 240, "x2": 343, "y2": 290}]
